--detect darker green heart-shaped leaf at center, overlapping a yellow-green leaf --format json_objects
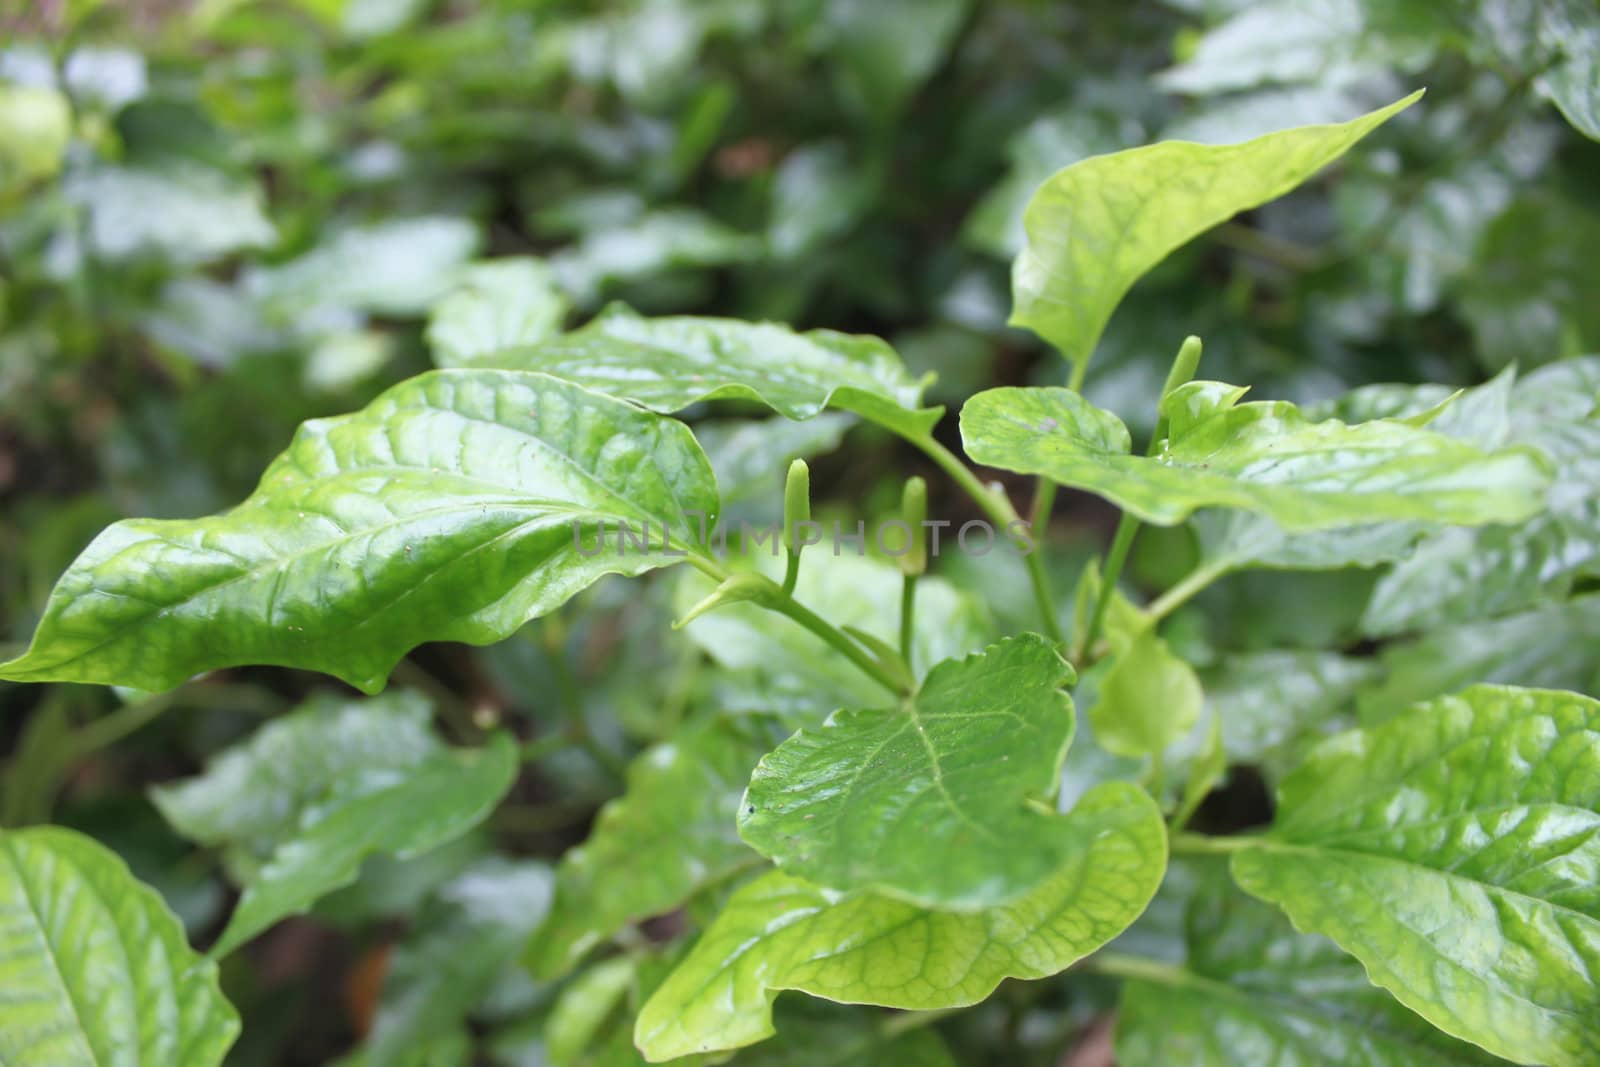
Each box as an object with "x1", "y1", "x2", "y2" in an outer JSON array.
[{"x1": 739, "y1": 633, "x2": 1082, "y2": 910}]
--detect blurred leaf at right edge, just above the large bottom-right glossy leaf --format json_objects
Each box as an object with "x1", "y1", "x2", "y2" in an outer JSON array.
[{"x1": 1358, "y1": 593, "x2": 1600, "y2": 723}]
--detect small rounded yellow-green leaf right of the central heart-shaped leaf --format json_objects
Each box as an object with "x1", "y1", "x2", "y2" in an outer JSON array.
[{"x1": 1088, "y1": 627, "x2": 1205, "y2": 758}]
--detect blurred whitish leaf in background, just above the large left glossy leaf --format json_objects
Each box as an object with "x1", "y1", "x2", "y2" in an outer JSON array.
[{"x1": 245, "y1": 216, "x2": 478, "y2": 322}]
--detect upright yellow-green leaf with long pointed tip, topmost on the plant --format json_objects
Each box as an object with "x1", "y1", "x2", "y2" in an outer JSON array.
[{"x1": 1011, "y1": 93, "x2": 1421, "y2": 371}]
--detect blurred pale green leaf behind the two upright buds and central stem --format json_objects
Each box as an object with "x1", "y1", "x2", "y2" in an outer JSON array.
[{"x1": 674, "y1": 550, "x2": 995, "y2": 713}]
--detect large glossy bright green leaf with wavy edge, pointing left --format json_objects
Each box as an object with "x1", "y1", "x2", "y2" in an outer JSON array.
[{"x1": 0, "y1": 370, "x2": 717, "y2": 693}]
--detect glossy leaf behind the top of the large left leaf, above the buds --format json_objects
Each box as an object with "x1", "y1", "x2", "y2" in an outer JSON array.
[{"x1": 464, "y1": 306, "x2": 942, "y2": 437}]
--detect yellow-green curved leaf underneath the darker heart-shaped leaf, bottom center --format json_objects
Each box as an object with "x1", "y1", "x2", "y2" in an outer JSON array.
[{"x1": 634, "y1": 782, "x2": 1166, "y2": 1061}]
